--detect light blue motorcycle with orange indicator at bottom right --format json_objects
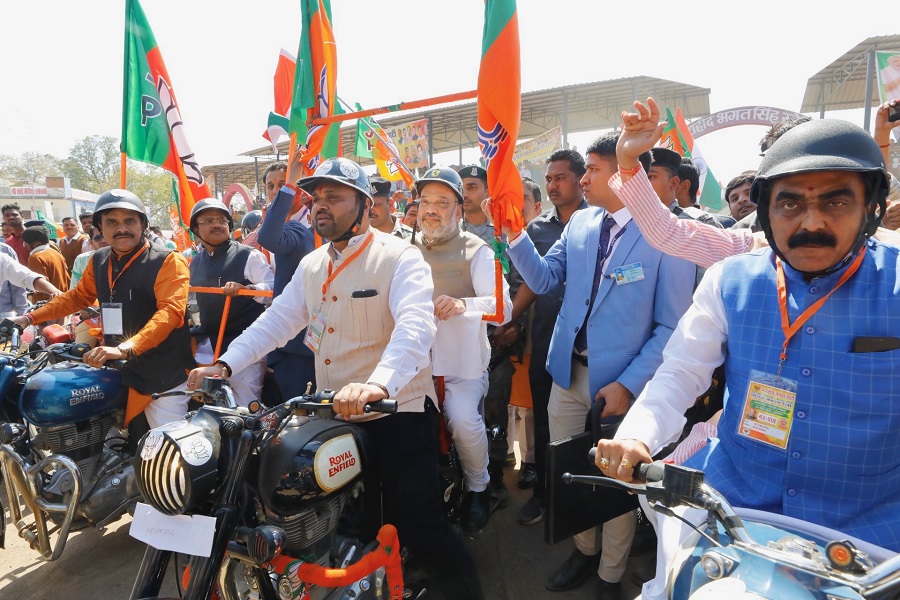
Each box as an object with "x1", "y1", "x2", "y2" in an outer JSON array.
[{"x1": 563, "y1": 448, "x2": 900, "y2": 600}]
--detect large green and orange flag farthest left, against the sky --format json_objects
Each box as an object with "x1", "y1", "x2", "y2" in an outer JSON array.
[{"x1": 121, "y1": 0, "x2": 212, "y2": 232}]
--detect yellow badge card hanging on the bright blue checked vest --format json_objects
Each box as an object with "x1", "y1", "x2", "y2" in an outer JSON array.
[{"x1": 738, "y1": 371, "x2": 797, "y2": 450}]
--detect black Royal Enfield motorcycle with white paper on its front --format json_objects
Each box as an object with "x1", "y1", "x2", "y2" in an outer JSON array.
[{"x1": 131, "y1": 378, "x2": 405, "y2": 600}]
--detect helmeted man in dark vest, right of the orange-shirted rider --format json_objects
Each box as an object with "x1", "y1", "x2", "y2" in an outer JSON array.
[{"x1": 190, "y1": 198, "x2": 275, "y2": 406}]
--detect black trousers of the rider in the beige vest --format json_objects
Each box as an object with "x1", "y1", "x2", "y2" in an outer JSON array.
[{"x1": 360, "y1": 398, "x2": 484, "y2": 600}]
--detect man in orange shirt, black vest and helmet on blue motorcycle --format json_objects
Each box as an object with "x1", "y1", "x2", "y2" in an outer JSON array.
[{"x1": 16, "y1": 190, "x2": 195, "y2": 442}]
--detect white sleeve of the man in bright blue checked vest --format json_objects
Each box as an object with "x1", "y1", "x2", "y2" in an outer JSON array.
[{"x1": 616, "y1": 262, "x2": 728, "y2": 454}]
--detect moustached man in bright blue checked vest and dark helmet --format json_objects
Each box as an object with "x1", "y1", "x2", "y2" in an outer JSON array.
[{"x1": 597, "y1": 103, "x2": 900, "y2": 598}]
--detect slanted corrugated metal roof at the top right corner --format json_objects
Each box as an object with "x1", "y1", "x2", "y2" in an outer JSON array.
[{"x1": 800, "y1": 35, "x2": 900, "y2": 115}]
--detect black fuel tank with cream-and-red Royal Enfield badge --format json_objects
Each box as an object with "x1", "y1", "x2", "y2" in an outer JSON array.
[{"x1": 259, "y1": 417, "x2": 366, "y2": 516}]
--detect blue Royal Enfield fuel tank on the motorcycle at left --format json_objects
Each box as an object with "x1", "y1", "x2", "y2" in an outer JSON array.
[{"x1": 19, "y1": 362, "x2": 128, "y2": 427}]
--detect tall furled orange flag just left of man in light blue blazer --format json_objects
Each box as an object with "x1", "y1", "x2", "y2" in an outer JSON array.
[{"x1": 478, "y1": 0, "x2": 524, "y2": 236}]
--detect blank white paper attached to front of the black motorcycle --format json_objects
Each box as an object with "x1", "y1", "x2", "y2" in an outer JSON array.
[{"x1": 128, "y1": 502, "x2": 216, "y2": 557}]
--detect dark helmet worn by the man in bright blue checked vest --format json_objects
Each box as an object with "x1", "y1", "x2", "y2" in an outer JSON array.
[{"x1": 750, "y1": 119, "x2": 889, "y2": 271}]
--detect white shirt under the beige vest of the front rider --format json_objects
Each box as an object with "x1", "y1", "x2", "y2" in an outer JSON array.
[{"x1": 221, "y1": 230, "x2": 436, "y2": 396}]
